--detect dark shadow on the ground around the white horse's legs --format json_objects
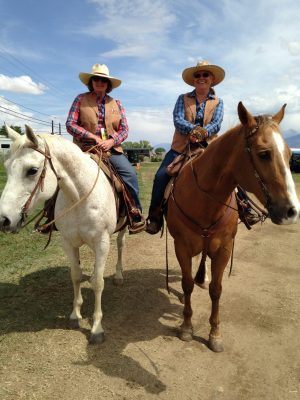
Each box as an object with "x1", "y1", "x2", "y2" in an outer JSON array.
[{"x1": 0, "y1": 266, "x2": 186, "y2": 394}]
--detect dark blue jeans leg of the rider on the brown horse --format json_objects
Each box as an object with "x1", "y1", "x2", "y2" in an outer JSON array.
[{"x1": 149, "y1": 149, "x2": 180, "y2": 211}]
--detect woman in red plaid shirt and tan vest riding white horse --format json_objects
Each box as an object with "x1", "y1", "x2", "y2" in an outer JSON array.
[{"x1": 66, "y1": 64, "x2": 145, "y2": 233}]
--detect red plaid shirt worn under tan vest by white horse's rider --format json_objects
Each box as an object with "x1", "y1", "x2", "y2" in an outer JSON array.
[{"x1": 66, "y1": 93, "x2": 128, "y2": 145}]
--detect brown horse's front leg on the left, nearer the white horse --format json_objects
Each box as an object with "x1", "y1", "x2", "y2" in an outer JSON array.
[{"x1": 175, "y1": 243, "x2": 194, "y2": 341}]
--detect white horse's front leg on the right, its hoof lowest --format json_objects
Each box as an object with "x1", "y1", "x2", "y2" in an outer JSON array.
[{"x1": 89, "y1": 233, "x2": 110, "y2": 344}]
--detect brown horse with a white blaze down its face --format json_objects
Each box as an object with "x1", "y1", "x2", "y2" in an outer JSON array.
[{"x1": 167, "y1": 102, "x2": 299, "y2": 352}]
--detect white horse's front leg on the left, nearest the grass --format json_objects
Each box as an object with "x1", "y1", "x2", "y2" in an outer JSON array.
[{"x1": 62, "y1": 238, "x2": 83, "y2": 329}]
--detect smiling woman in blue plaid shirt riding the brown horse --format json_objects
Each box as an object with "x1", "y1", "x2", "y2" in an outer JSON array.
[{"x1": 146, "y1": 61, "x2": 225, "y2": 234}]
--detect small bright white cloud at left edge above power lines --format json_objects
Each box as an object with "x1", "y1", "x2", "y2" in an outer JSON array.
[{"x1": 0, "y1": 74, "x2": 47, "y2": 95}]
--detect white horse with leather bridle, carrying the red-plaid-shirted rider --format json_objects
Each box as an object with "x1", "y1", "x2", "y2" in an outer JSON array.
[{"x1": 0, "y1": 127, "x2": 125, "y2": 343}]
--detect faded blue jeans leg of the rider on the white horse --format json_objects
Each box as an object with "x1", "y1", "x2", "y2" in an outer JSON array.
[{"x1": 109, "y1": 153, "x2": 142, "y2": 211}]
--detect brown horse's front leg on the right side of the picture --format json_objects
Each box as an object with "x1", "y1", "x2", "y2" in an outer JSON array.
[{"x1": 208, "y1": 245, "x2": 232, "y2": 352}]
